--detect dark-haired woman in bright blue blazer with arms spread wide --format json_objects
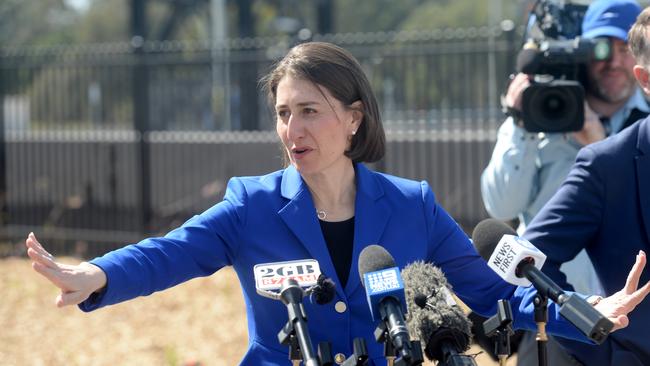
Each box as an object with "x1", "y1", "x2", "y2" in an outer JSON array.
[{"x1": 26, "y1": 42, "x2": 648, "y2": 365}]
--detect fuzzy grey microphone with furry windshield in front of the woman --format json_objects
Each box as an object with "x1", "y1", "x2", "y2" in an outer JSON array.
[{"x1": 402, "y1": 262, "x2": 476, "y2": 366}]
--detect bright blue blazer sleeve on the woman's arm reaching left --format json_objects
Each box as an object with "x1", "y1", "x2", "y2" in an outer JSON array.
[{"x1": 79, "y1": 178, "x2": 247, "y2": 311}]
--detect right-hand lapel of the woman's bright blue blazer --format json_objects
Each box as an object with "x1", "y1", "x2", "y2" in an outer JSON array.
[{"x1": 345, "y1": 164, "x2": 390, "y2": 294}]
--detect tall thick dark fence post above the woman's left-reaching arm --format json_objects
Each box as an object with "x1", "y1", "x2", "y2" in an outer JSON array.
[{"x1": 131, "y1": 0, "x2": 153, "y2": 234}]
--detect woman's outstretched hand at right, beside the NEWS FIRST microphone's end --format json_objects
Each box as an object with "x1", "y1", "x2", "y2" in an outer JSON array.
[{"x1": 595, "y1": 250, "x2": 650, "y2": 331}]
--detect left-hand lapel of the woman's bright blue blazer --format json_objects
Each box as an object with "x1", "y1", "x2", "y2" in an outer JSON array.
[{"x1": 278, "y1": 166, "x2": 343, "y2": 296}]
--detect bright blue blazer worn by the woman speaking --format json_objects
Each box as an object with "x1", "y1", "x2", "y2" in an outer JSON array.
[{"x1": 80, "y1": 164, "x2": 583, "y2": 366}]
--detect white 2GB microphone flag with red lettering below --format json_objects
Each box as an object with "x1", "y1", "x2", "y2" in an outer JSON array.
[{"x1": 253, "y1": 259, "x2": 321, "y2": 291}]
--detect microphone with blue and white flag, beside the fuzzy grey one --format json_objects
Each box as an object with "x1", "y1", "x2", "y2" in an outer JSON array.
[{"x1": 359, "y1": 245, "x2": 422, "y2": 364}]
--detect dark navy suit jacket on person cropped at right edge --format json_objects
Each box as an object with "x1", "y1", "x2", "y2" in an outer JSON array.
[{"x1": 524, "y1": 118, "x2": 650, "y2": 365}]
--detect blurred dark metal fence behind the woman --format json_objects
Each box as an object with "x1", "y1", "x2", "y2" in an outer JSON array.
[{"x1": 0, "y1": 28, "x2": 516, "y2": 257}]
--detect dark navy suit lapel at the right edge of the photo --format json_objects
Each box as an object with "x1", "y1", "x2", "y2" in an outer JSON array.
[{"x1": 636, "y1": 118, "x2": 650, "y2": 246}]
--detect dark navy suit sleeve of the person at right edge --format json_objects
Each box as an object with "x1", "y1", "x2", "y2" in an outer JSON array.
[{"x1": 524, "y1": 134, "x2": 647, "y2": 366}]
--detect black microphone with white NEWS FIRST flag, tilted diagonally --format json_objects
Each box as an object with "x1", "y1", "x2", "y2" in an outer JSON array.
[{"x1": 472, "y1": 219, "x2": 614, "y2": 344}]
